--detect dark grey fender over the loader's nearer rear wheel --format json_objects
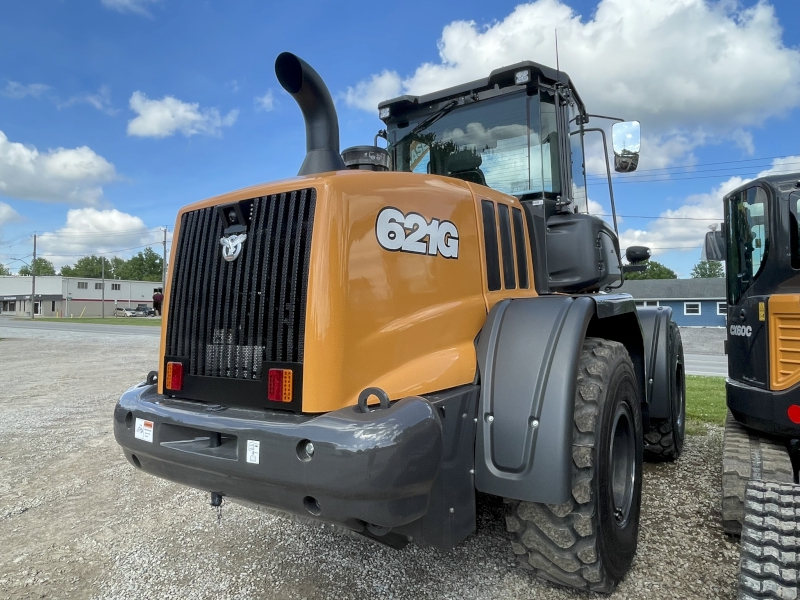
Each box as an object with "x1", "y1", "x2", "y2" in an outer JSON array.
[{"x1": 475, "y1": 295, "x2": 644, "y2": 504}]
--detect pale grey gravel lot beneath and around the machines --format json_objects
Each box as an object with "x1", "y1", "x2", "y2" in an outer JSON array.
[{"x1": 0, "y1": 329, "x2": 738, "y2": 600}]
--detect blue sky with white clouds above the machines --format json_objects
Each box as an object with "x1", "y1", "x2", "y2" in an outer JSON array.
[{"x1": 0, "y1": 0, "x2": 800, "y2": 277}]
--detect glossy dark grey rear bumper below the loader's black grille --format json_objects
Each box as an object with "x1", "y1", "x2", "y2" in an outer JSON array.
[{"x1": 114, "y1": 385, "x2": 442, "y2": 528}]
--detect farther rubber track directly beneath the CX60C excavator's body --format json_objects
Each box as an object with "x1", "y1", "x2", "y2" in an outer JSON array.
[{"x1": 722, "y1": 411, "x2": 794, "y2": 535}]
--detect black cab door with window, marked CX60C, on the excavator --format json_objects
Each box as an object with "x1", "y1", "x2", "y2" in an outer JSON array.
[{"x1": 725, "y1": 186, "x2": 771, "y2": 389}]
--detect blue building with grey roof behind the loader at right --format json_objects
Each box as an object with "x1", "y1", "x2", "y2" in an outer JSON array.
[{"x1": 617, "y1": 277, "x2": 728, "y2": 327}]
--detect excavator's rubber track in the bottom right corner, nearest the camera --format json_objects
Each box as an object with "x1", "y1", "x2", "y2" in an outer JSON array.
[{"x1": 738, "y1": 481, "x2": 800, "y2": 600}]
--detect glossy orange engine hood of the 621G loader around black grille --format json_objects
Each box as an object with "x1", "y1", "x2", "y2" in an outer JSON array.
[{"x1": 159, "y1": 171, "x2": 536, "y2": 413}]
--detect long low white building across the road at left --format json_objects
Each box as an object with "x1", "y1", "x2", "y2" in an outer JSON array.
[{"x1": 0, "y1": 275, "x2": 164, "y2": 318}]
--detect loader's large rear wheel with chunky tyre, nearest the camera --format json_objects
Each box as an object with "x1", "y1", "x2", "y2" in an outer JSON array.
[{"x1": 506, "y1": 338, "x2": 643, "y2": 593}]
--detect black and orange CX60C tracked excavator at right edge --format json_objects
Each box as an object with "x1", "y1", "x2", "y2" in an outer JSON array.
[{"x1": 704, "y1": 172, "x2": 800, "y2": 599}]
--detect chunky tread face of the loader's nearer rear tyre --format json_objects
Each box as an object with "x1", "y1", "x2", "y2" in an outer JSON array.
[{"x1": 505, "y1": 338, "x2": 627, "y2": 593}]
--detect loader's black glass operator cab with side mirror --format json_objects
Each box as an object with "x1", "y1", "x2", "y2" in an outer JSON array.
[{"x1": 378, "y1": 61, "x2": 639, "y2": 294}]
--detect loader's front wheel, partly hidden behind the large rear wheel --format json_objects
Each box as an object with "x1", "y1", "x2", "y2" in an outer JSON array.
[{"x1": 644, "y1": 321, "x2": 686, "y2": 462}]
